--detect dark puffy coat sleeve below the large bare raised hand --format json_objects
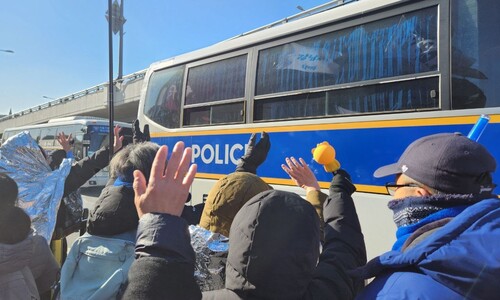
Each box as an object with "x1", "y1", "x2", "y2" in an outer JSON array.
[{"x1": 123, "y1": 213, "x2": 201, "y2": 299}]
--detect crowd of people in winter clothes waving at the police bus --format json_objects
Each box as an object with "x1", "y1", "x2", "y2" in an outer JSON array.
[{"x1": 0, "y1": 121, "x2": 500, "y2": 299}]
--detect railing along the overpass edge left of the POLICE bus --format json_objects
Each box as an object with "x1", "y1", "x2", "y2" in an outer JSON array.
[{"x1": 0, "y1": 70, "x2": 146, "y2": 122}]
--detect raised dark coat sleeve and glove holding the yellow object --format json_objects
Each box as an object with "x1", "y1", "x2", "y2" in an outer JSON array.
[{"x1": 306, "y1": 170, "x2": 366, "y2": 299}]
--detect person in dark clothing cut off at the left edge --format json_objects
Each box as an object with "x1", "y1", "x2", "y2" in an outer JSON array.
[{"x1": 0, "y1": 173, "x2": 59, "y2": 299}]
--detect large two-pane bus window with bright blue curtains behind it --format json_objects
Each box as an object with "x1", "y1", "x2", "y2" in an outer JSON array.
[{"x1": 254, "y1": 7, "x2": 439, "y2": 121}]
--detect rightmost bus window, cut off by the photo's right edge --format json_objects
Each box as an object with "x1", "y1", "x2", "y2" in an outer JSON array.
[{"x1": 451, "y1": 0, "x2": 500, "y2": 109}]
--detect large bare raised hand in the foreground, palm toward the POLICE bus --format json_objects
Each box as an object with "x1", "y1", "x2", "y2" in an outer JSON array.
[{"x1": 134, "y1": 142, "x2": 197, "y2": 218}]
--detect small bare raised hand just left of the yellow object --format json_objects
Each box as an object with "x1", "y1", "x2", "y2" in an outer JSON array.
[{"x1": 281, "y1": 157, "x2": 321, "y2": 192}]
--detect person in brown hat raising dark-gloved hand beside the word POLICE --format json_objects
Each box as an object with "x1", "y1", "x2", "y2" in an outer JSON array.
[{"x1": 189, "y1": 132, "x2": 272, "y2": 291}]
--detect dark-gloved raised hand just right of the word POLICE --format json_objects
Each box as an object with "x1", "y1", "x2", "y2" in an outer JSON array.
[{"x1": 236, "y1": 131, "x2": 271, "y2": 174}]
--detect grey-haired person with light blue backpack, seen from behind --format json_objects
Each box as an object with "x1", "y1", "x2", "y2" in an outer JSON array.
[{"x1": 60, "y1": 142, "x2": 159, "y2": 299}]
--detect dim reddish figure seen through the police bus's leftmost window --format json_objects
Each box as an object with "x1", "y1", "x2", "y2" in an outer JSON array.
[{"x1": 147, "y1": 83, "x2": 181, "y2": 128}]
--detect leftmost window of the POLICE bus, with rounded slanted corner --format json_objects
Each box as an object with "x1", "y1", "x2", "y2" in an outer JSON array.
[{"x1": 144, "y1": 66, "x2": 184, "y2": 128}]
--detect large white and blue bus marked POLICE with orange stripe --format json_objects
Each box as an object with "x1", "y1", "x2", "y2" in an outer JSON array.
[{"x1": 138, "y1": 0, "x2": 500, "y2": 257}]
